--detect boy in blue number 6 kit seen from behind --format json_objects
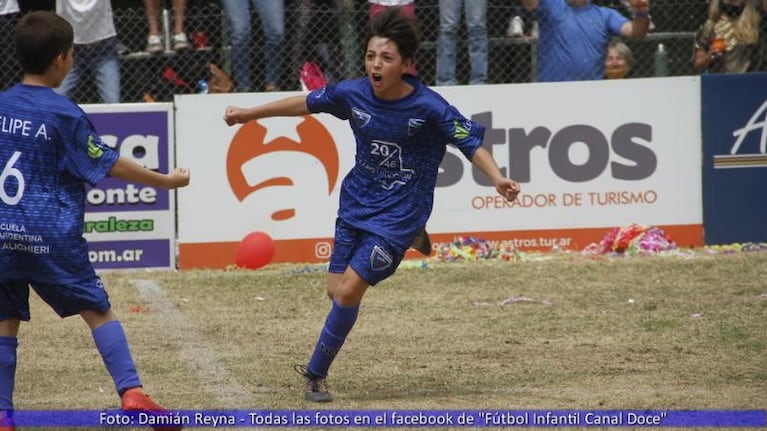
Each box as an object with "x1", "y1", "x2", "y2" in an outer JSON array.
[{"x1": 0, "y1": 12, "x2": 189, "y2": 429}]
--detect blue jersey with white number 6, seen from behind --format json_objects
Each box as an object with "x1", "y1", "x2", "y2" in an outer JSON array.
[{"x1": 0, "y1": 84, "x2": 118, "y2": 284}]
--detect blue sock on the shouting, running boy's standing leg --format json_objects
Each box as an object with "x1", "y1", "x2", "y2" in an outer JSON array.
[{"x1": 307, "y1": 300, "x2": 360, "y2": 377}]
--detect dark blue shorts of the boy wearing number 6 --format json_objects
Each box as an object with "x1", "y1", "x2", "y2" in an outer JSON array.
[{"x1": 0, "y1": 276, "x2": 111, "y2": 321}]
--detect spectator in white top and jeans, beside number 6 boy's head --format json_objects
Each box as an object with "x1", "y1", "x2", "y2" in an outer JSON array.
[{"x1": 56, "y1": 0, "x2": 120, "y2": 103}]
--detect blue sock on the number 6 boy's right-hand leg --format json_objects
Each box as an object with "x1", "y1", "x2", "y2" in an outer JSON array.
[{"x1": 93, "y1": 320, "x2": 141, "y2": 395}]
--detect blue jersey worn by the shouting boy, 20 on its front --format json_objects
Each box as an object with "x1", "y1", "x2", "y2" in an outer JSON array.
[{"x1": 306, "y1": 77, "x2": 485, "y2": 247}]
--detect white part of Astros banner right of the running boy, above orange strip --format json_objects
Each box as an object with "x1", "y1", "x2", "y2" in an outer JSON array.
[{"x1": 429, "y1": 77, "x2": 702, "y2": 232}]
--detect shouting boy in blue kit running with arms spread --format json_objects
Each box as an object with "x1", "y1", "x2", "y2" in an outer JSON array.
[{"x1": 224, "y1": 7, "x2": 520, "y2": 402}]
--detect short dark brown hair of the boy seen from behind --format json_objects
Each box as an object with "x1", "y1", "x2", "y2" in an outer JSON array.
[{"x1": 16, "y1": 11, "x2": 74, "y2": 75}]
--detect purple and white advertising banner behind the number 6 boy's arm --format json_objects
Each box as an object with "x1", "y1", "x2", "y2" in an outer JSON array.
[{"x1": 82, "y1": 103, "x2": 176, "y2": 270}]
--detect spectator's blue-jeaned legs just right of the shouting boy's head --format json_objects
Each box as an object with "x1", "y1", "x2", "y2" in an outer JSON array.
[{"x1": 436, "y1": 0, "x2": 486, "y2": 85}]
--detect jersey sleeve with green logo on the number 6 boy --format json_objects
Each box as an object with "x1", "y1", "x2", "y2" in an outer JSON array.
[{"x1": 63, "y1": 115, "x2": 119, "y2": 185}]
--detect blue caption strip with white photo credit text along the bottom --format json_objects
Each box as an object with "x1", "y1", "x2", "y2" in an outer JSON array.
[{"x1": 7, "y1": 410, "x2": 767, "y2": 428}]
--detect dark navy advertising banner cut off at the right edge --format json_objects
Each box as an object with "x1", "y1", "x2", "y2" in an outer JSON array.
[{"x1": 702, "y1": 73, "x2": 767, "y2": 244}]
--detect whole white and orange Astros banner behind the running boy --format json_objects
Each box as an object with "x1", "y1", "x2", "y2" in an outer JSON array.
[{"x1": 175, "y1": 77, "x2": 703, "y2": 268}]
